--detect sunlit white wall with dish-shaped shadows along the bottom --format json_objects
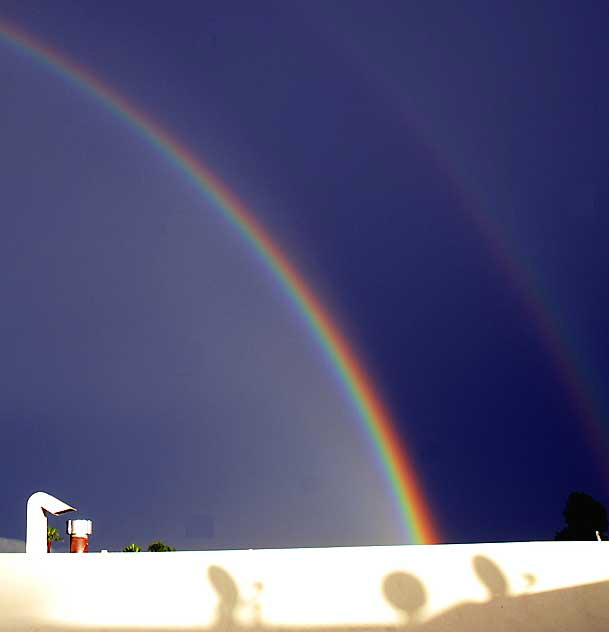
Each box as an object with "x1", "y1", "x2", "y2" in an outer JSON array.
[{"x1": 0, "y1": 542, "x2": 609, "y2": 632}]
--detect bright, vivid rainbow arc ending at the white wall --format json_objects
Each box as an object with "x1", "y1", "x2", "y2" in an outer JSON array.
[{"x1": 0, "y1": 20, "x2": 440, "y2": 544}]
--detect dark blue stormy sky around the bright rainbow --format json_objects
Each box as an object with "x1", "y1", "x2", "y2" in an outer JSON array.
[{"x1": 0, "y1": 0, "x2": 609, "y2": 549}]
